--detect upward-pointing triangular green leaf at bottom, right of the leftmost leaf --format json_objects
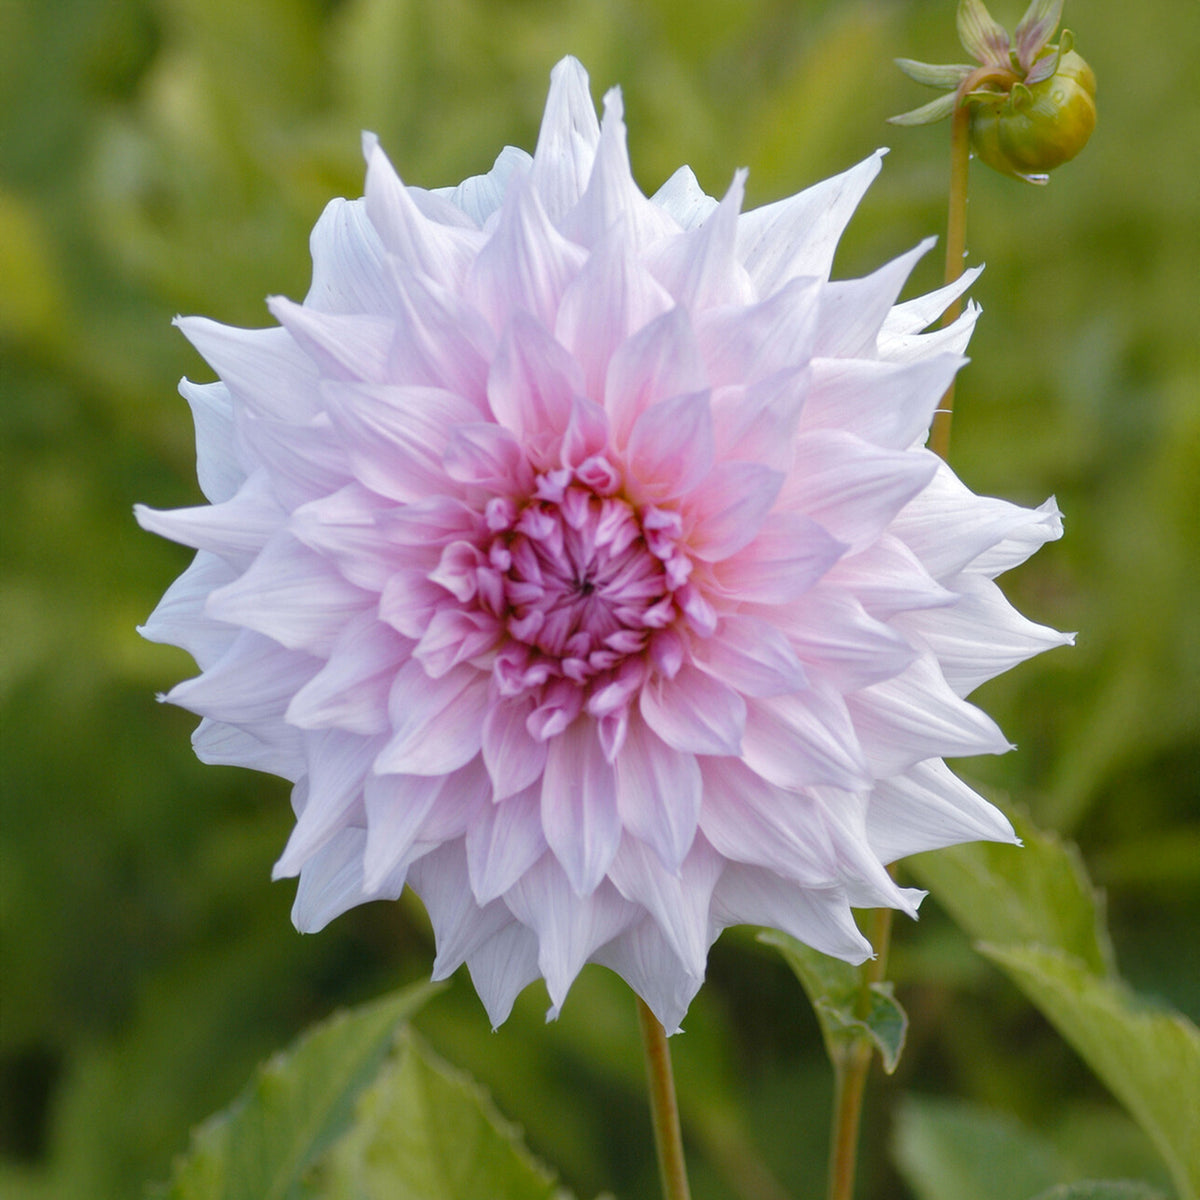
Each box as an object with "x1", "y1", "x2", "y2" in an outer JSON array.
[{"x1": 311, "y1": 1030, "x2": 563, "y2": 1200}]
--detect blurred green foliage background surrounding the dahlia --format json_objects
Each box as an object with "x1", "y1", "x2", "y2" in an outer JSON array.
[{"x1": 0, "y1": 0, "x2": 1200, "y2": 1200}]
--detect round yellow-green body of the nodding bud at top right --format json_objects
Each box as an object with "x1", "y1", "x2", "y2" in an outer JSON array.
[{"x1": 967, "y1": 50, "x2": 1096, "y2": 182}]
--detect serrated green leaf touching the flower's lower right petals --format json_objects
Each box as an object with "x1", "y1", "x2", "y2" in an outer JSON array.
[{"x1": 905, "y1": 812, "x2": 1114, "y2": 974}]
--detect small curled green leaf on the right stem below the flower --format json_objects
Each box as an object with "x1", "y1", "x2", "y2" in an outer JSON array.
[{"x1": 758, "y1": 930, "x2": 908, "y2": 1075}]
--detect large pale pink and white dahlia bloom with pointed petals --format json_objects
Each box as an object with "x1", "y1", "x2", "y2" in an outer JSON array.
[{"x1": 137, "y1": 59, "x2": 1068, "y2": 1030}]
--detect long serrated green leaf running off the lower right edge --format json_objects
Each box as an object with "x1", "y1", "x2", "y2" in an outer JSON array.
[{"x1": 980, "y1": 944, "x2": 1200, "y2": 1200}]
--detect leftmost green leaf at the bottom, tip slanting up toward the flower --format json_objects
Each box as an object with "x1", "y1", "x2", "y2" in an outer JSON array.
[{"x1": 150, "y1": 984, "x2": 437, "y2": 1200}]
